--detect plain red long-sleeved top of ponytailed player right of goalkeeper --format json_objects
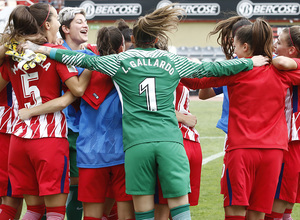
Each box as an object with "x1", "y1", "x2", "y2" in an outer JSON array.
[{"x1": 182, "y1": 60, "x2": 300, "y2": 151}]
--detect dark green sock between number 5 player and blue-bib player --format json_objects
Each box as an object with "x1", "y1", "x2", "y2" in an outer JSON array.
[{"x1": 66, "y1": 185, "x2": 83, "y2": 220}]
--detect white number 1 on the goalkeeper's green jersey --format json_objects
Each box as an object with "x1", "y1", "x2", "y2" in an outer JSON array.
[{"x1": 139, "y1": 78, "x2": 157, "y2": 111}]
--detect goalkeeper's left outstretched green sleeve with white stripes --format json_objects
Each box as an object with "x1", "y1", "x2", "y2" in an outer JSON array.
[{"x1": 50, "y1": 49, "x2": 120, "y2": 76}]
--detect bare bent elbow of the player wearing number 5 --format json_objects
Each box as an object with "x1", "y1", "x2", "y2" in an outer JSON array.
[{"x1": 65, "y1": 69, "x2": 92, "y2": 97}]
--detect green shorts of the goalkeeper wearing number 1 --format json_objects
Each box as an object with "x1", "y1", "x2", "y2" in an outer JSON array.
[{"x1": 125, "y1": 142, "x2": 190, "y2": 198}]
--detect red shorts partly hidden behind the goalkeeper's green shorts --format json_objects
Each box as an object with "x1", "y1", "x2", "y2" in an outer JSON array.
[{"x1": 155, "y1": 139, "x2": 202, "y2": 206}]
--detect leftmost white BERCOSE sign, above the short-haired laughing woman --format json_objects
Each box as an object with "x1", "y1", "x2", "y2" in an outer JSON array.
[{"x1": 80, "y1": 1, "x2": 142, "y2": 19}]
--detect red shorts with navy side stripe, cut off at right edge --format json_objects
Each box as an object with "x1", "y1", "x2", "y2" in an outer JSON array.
[{"x1": 275, "y1": 141, "x2": 300, "y2": 203}]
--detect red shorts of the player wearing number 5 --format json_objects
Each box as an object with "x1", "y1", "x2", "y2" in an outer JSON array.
[{"x1": 8, "y1": 135, "x2": 70, "y2": 196}]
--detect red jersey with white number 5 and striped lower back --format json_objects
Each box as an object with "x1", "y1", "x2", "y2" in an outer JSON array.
[{"x1": 1, "y1": 44, "x2": 78, "y2": 139}]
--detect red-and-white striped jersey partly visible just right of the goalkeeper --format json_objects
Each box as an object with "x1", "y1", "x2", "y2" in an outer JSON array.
[{"x1": 175, "y1": 82, "x2": 200, "y2": 143}]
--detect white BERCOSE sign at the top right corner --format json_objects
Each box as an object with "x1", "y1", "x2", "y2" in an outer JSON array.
[{"x1": 236, "y1": 0, "x2": 300, "y2": 18}]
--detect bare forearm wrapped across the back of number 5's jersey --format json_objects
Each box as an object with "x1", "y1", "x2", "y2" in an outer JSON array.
[{"x1": 19, "y1": 91, "x2": 77, "y2": 120}]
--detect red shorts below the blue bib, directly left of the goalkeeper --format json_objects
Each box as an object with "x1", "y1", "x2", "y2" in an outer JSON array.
[{"x1": 78, "y1": 164, "x2": 132, "y2": 203}]
